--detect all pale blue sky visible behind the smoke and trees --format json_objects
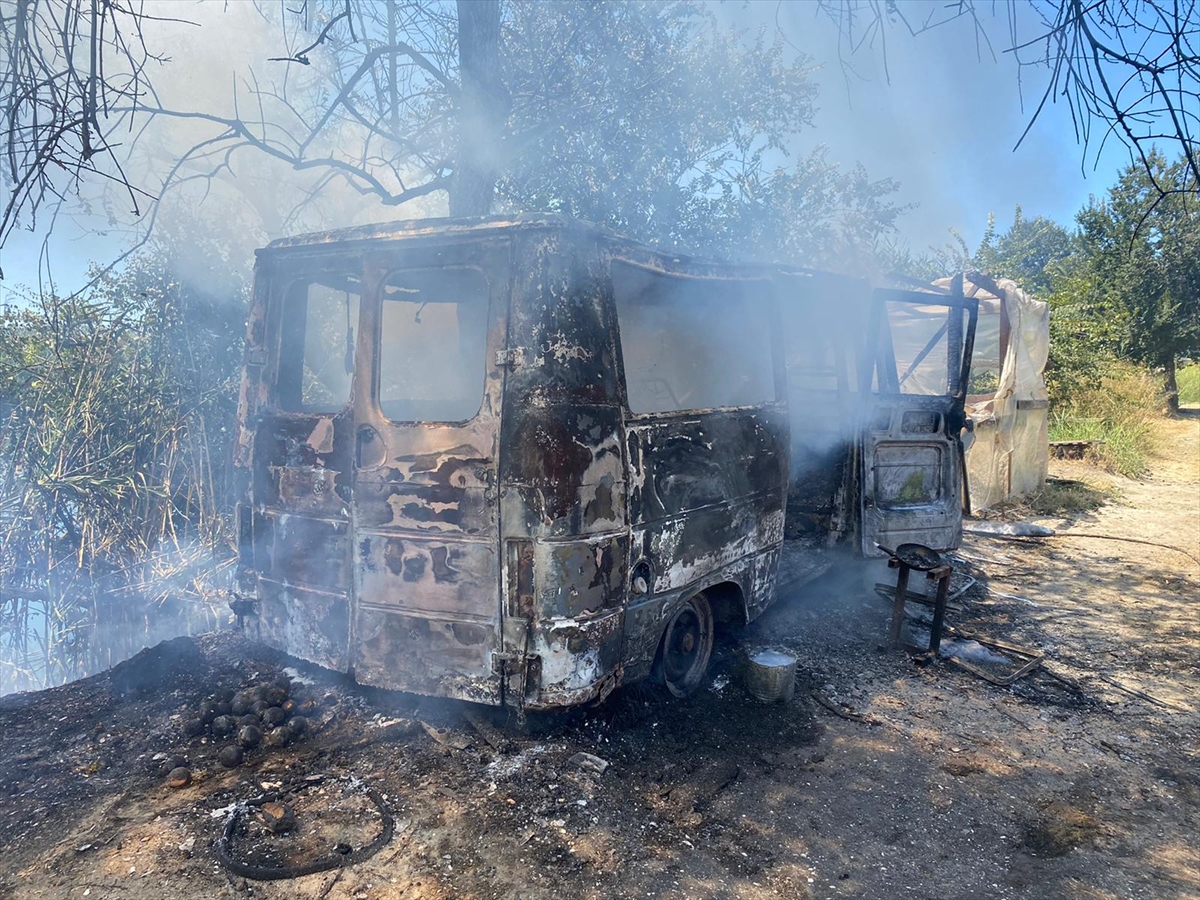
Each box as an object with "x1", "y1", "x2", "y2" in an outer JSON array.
[{"x1": 0, "y1": 0, "x2": 1129, "y2": 302}]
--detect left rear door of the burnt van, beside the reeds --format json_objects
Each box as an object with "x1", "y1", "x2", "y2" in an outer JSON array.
[{"x1": 238, "y1": 254, "x2": 361, "y2": 671}]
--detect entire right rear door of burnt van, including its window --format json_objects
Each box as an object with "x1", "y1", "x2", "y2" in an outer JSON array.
[{"x1": 353, "y1": 240, "x2": 510, "y2": 703}]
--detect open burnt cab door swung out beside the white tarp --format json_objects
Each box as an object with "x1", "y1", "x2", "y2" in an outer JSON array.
[{"x1": 860, "y1": 277, "x2": 978, "y2": 556}]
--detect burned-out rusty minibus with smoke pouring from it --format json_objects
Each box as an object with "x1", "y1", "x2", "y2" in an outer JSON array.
[{"x1": 235, "y1": 217, "x2": 974, "y2": 709}]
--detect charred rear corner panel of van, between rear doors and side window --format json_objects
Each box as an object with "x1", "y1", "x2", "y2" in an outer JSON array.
[{"x1": 500, "y1": 232, "x2": 629, "y2": 708}]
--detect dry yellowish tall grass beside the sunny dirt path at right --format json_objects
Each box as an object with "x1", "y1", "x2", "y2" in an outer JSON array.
[{"x1": 1050, "y1": 364, "x2": 1163, "y2": 478}]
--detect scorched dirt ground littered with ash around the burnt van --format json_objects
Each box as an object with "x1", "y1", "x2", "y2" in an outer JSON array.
[{"x1": 0, "y1": 410, "x2": 1200, "y2": 900}]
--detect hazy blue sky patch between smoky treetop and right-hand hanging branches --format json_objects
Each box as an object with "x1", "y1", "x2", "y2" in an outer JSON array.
[{"x1": 716, "y1": 0, "x2": 1129, "y2": 252}]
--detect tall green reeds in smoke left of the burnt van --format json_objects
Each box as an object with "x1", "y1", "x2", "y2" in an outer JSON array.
[{"x1": 0, "y1": 250, "x2": 245, "y2": 692}]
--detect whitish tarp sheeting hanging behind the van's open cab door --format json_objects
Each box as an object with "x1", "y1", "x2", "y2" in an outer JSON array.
[{"x1": 935, "y1": 278, "x2": 1050, "y2": 512}]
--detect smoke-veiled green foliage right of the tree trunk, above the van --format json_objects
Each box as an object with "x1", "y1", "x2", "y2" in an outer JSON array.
[{"x1": 497, "y1": 1, "x2": 901, "y2": 271}]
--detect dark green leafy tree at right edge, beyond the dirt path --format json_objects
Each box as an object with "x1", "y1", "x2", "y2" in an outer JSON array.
[{"x1": 1078, "y1": 151, "x2": 1200, "y2": 410}]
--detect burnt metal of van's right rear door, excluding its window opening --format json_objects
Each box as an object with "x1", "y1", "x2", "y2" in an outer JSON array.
[{"x1": 354, "y1": 240, "x2": 510, "y2": 702}]
